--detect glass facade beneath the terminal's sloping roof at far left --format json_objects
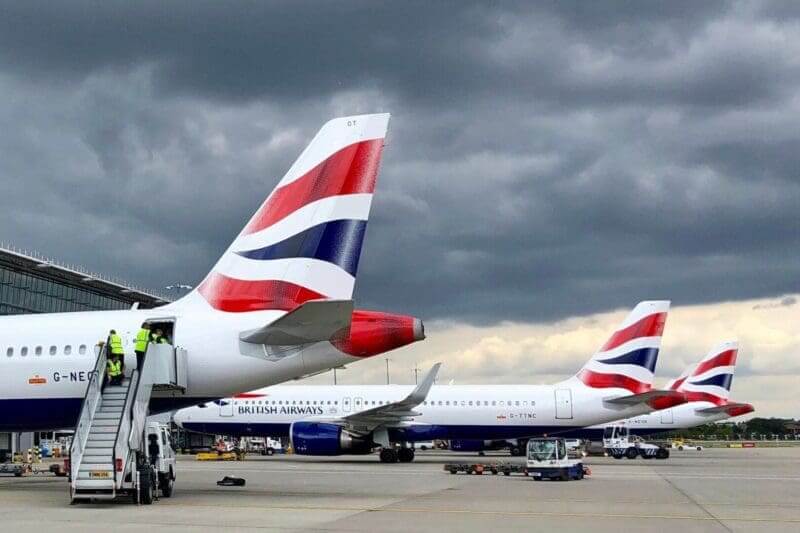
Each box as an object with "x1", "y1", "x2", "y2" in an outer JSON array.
[{"x1": 0, "y1": 265, "x2": 131, "y2": 315}]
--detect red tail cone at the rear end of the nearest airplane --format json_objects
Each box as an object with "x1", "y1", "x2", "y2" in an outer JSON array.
[{"x1": 331, "y1": 309, "x2": 425, "y2": 357}]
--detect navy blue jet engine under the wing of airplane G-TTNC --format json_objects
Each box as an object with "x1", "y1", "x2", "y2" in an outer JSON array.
[{"x1": 289, "y1": 422, "x2": 373, "y2": 455}]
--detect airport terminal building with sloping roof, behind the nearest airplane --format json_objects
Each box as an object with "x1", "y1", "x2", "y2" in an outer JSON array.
[{"x1": 0, "y1": 247, "x2": 170, "y2": 455}]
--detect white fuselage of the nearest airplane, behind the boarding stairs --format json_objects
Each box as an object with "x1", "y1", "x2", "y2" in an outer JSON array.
[{"x1": 0, "y1": 306, "x2": 368, "y2": 431}]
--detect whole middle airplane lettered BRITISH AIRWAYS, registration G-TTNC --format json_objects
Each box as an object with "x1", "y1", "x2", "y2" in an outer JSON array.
[{"x1": 173, "y1": 301, "x2": 686, "y2": 463}]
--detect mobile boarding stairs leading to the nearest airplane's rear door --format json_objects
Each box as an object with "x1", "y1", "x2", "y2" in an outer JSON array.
[{"x1": 69, "y1": 343, "x2": 187, "y2": 503}]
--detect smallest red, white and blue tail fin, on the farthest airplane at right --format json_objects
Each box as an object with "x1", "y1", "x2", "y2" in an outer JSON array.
[{"x1": 676, "y1": 341, "x2": 739, "y2": 405}]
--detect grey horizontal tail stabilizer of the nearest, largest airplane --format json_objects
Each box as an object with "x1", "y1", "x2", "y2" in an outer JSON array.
[{"x1": 239, "y1": 300, "x2": 353, "y2": 346}]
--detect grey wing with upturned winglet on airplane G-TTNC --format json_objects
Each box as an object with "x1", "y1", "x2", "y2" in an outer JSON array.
[{"x1": 306, "y1": 363, "x2": 442, "y2": 433}]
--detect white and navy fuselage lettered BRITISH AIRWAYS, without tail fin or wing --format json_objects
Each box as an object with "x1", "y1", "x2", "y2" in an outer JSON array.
[{"x1": 174, "y1": 379, "x2": 672, "y2": 441}]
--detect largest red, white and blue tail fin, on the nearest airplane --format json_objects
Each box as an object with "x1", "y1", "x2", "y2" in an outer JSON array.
[{"x1": 185, "y1": 114, "x2": 389, "y2": 313}]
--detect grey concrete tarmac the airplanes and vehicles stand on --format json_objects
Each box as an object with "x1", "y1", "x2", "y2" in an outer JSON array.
[{"x1": 0, "y1": 447, "x2": 800, "y2": 533}]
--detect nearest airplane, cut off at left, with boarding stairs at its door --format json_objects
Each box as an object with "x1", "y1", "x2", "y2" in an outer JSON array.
[{"x1": 0, "y1": 114, "x2": 425, "y2": 431}]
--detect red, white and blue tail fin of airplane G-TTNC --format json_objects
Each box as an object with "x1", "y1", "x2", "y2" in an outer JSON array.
[{"x1": 576, "y1": 301, "x2": 669, "y2": 394}]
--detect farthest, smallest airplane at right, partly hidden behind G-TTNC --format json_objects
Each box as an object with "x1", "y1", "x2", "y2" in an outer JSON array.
[{"x1": 589, "y1": 341, "x2": 755, "y2": 438}]
